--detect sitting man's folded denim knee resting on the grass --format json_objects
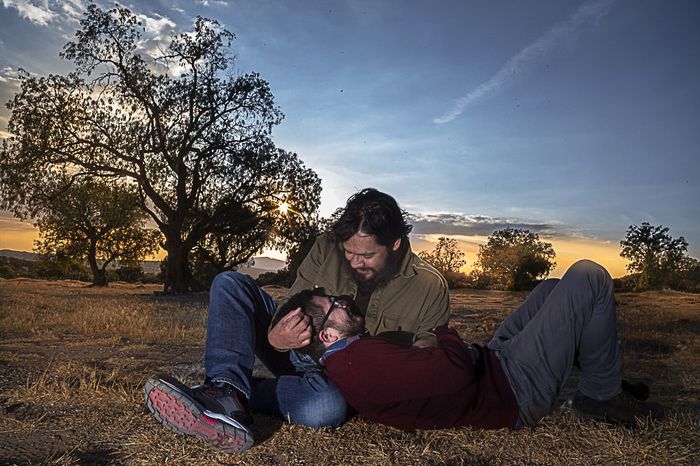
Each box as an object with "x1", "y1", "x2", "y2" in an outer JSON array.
[{"x1": 282, "y1": 385, "x2": 348, "y2": 428}]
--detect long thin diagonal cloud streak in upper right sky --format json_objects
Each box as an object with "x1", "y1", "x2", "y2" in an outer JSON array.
[{"x1": 433, "y1": 0, "x2": 615, "y2": 124}]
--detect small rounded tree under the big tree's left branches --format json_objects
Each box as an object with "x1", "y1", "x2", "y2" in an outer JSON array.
[{"x1": 33, "y1": 180, "x2": 160, "y2": 286}]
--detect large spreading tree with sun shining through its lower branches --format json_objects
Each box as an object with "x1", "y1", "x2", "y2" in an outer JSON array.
[{"x1": 0, "y1": 4, "x2": 321, "y2": 292}]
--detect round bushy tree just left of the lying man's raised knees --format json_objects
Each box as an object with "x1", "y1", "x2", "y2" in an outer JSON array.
[{"x1": 477, "y1": 228, "x2": 556, "y2": 290}]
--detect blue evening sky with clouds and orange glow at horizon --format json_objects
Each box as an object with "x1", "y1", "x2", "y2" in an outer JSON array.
[{"x1": 0, "y1": 0, "x2": 700, "y2": 276}]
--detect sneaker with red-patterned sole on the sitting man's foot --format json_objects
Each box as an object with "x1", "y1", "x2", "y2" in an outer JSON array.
[{"x1": 144, "y1": 375, "x2": 253, "y2": 453}]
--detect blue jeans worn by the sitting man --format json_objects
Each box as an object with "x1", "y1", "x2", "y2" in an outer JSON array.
[{"x1": 204, "y1": 272, "x2": 347, "y2": 427}]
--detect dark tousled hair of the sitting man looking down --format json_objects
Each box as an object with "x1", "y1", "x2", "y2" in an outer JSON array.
[{"x1": 331, "y1": 188, "x2": 413, "y2": 247}]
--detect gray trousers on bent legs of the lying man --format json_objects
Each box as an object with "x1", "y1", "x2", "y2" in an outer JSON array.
[{"x1": 488, "y1": 260, "x2": 622, "y2": 426}]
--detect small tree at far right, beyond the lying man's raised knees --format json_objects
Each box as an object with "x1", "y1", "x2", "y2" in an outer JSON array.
[{"x1": 620, "y1": 222, "x2": 694, "y2": 291}]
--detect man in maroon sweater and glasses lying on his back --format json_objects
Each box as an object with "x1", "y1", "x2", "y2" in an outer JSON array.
[{"x1": 278, "y1": 261, "x2": 663, "y2": 430}]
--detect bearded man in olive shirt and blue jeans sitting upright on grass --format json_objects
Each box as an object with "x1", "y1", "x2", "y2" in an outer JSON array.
[{"x1": 145, "y1": 188, "x2": 449, "y2": 452}]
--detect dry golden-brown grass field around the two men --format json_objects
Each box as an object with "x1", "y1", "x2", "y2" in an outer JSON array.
[{"x1": 0, "y1": 279, "x2": 700, "y2": 465}]
